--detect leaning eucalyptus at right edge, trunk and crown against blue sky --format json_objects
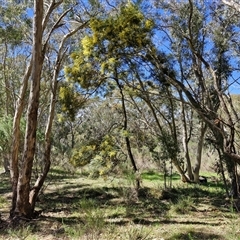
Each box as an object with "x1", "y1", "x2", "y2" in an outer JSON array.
[{"x1": 150, "y1": 0, "x2": 240, "y2": 195}]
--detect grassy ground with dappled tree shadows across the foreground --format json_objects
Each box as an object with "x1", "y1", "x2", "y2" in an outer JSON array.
[{"x1": 0, "y1": 170, "x2": 240, "y2": 240}]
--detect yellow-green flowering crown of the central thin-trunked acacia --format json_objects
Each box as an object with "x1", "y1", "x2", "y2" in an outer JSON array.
[{"x1": 65, "y1": 3, "x2": 153, "y2": 88}]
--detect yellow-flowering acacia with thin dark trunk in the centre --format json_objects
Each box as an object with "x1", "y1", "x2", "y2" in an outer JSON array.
[{"x1": 65, "y1": 3, "x2": 156, "y2": 188}]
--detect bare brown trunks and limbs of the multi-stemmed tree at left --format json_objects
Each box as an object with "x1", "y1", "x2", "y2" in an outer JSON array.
[{"x1": 10, "y1": 0, "x2": 87, "y2": 218}]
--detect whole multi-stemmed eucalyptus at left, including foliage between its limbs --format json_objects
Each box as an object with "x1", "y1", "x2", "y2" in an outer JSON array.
[{"x1": 7, "y1": 0, "x2": 94, "y2": 218}]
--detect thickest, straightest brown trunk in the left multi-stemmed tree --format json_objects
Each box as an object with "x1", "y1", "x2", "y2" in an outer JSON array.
[{"x1": 14, "y1": 0, "x2": 43, "y2": 217}]
